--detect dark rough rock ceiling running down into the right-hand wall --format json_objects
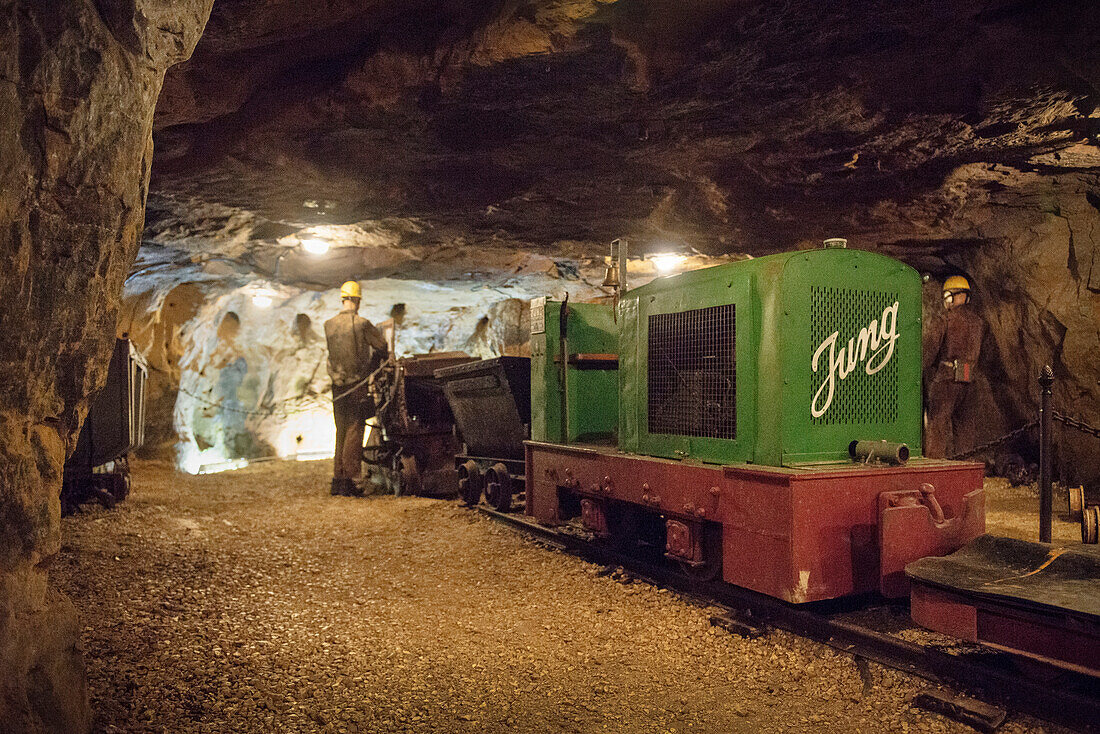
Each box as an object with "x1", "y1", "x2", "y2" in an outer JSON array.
[{"x1": 141, "y1": 0, "x2": 1100, "y2": 488}]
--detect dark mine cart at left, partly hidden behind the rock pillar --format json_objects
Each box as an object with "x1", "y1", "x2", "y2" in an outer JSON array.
[{"x1": 62, "y1": 339, "x2": 146, "y2": 513}]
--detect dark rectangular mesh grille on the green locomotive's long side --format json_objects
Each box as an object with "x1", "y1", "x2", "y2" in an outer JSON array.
[{"x1": 648, "y1": 304, "x2": 737, "y2": 439}]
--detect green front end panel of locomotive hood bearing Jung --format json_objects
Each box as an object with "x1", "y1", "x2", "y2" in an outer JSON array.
[{"x1": 778, "y1": 250, "x2": 922, "y2": 464}]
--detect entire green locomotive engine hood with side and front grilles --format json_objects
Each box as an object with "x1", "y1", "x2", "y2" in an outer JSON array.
[{"x1": 617, "y1": 249, "x2": 921, "y2": 465}]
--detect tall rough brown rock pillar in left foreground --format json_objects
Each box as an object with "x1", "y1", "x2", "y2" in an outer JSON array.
[{"x1": 0, "y1": 0, "x2": 211, "y2": 734}]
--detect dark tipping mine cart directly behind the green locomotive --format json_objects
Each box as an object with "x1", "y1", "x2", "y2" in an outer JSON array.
[{"x1": 436, "y1": 357, "x2": 531, "y2": 512}]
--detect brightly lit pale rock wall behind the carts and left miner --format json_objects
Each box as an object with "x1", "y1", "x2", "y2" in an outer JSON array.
[{"x1": 119, "y1": 256, "x2": 633, "y2": 472}]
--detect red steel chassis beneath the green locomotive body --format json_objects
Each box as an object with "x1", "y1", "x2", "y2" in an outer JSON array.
[{"x1": 526, "y1": 441, "x2": 986, "y2": 603}]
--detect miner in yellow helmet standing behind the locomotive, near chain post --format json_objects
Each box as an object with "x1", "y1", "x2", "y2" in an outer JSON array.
[{"x1": 924, "y1": 275, "x2": 986, "y2": 459}]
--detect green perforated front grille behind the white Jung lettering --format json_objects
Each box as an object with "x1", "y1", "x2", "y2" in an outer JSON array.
[{"x1": 807, "y1": 286, "x2": 897, "y2": 426}]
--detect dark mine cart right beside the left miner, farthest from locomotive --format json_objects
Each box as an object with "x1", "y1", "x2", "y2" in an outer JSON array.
[{"x1": 364, "y1": 352, "x2": 474, "y2": 496}]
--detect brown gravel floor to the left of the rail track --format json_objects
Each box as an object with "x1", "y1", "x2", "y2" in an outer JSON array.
[{"x1": 54, "y1": 462, "x2": 1056, "y2": 733}]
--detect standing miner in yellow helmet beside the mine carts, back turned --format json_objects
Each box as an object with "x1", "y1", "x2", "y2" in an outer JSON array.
[{"x1": 325, "y1": 281, "x2": 387, "y2": 496}]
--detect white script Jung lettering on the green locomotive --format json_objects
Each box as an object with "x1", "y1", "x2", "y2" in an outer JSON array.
[{"x1": 810, "y1": 300, "x2": 898, "y2": 418}]
